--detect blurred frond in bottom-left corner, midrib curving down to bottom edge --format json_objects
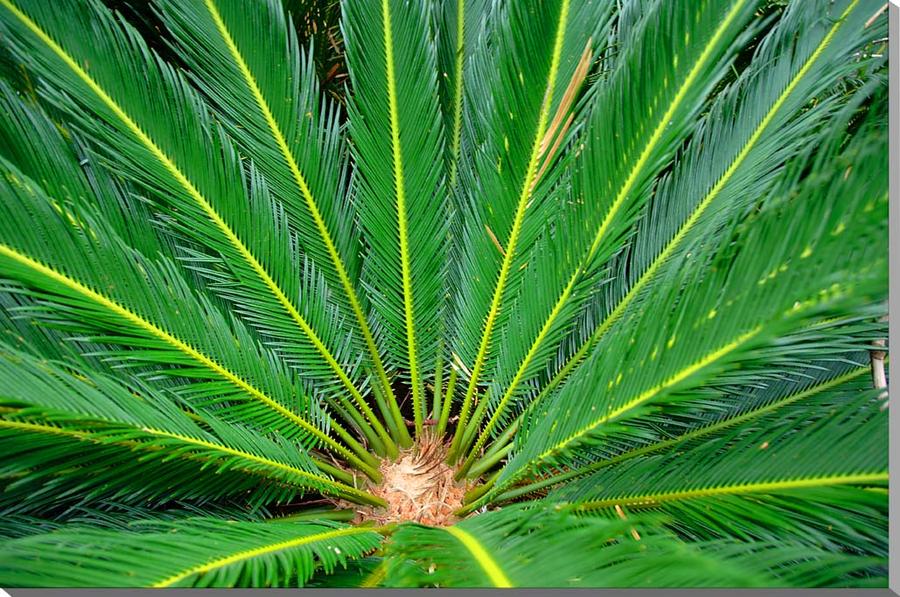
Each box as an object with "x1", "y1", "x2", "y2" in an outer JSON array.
[{"x1": 0, "y1": 518, "x2": 381, "y2": 587}]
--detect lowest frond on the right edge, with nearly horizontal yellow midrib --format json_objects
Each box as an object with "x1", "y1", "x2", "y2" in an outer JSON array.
[{"x1": 549, "y1": 388, "x2": 888, "y2": 555}]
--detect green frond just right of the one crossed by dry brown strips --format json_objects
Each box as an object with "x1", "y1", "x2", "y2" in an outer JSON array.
[{"x1": 463, "y1": 2, "x2": 753, "y2": 470}]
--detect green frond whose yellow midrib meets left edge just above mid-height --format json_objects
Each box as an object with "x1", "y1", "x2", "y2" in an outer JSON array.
[{"x1": 0, "y1": 166, "x2": 384, "y2": 472}]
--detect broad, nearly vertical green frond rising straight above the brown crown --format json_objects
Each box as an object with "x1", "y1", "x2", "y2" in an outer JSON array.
[{"x1": 343, "y1": 0, "x2": 448, "y2": 433}]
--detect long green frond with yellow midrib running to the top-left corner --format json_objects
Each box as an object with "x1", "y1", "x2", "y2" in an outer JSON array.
[{"x1": 3, "y1": 0, "x2": 398, "y2": 452}]
